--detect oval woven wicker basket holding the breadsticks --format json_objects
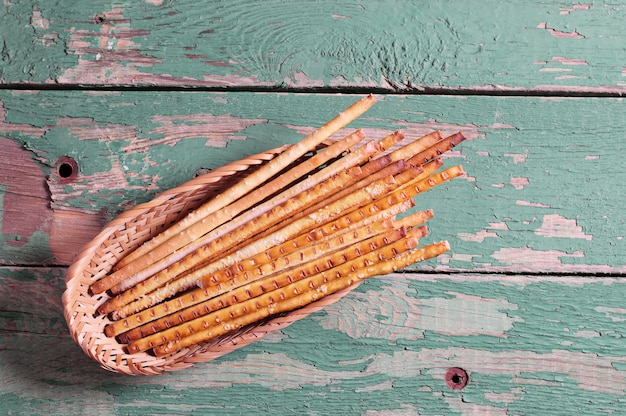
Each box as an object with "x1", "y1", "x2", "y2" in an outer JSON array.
[{"x1": 63, "y1": 146, "x2": 357, "y2": 375}]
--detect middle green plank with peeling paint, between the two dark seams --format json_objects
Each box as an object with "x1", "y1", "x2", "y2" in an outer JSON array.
[{"x1": 0, "y1": 91, "x2": 626, "y2": 274}]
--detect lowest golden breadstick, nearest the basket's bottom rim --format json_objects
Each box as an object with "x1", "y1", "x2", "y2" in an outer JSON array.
[{"x1": 148, "y1": 241, "x2": 450, "y2": 357}]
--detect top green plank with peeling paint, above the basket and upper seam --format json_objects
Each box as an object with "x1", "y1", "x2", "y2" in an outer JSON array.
[{"x1": 0, "y1": 0, "x2": 626, "y2": 93}]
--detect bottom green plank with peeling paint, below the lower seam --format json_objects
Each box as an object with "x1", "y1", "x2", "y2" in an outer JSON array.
[{"x1": 0, "y1": 267, "x2": 626, "y2": 415}]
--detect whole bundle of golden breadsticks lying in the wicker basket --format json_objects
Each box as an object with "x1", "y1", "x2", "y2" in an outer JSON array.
[{"x1": 90, "y1": 96, "x2": 465, "y2": 356}]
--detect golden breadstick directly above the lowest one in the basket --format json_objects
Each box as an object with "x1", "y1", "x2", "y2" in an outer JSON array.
[{"x1": 126, "y1": 232, "x2": 418, "y2": 353}]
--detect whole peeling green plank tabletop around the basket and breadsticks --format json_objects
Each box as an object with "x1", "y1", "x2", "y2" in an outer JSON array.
[{"x1": 0, "y1": 0, "x2": 626, "y2": 415}]
